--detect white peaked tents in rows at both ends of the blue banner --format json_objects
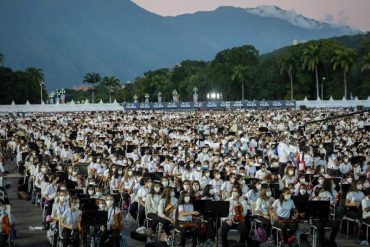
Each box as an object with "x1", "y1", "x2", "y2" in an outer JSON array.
[{"x1": 0, "y1": 96, "x2": 370, "y2": 113}]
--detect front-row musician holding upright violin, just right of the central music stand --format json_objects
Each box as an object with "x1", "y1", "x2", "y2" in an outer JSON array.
[{"x1": 221, "y1": 186, "x2": 250, "y2": 247}]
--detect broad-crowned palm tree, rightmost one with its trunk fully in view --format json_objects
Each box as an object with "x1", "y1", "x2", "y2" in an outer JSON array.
[{"x1": 331, "y1": 48, "x2": 355, "y2": 99}]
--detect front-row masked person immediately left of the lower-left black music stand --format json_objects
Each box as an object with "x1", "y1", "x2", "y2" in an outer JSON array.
[{"x1": 60, "y1": 197, "x2": 82, "y2": 247}]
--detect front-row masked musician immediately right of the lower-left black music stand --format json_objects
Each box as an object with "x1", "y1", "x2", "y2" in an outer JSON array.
[{"x1": 99, "y1": 195, "x2": 123, "y2": 247}]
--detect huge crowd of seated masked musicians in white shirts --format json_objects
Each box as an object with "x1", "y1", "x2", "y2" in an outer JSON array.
[{"x1": 0, "y1": 109, "x2": 370, "y2": 247}]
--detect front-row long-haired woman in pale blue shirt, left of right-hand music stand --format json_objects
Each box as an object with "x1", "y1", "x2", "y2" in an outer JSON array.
[{"x1": 270, "y1": 188, "x2": 299, "y2": 243}]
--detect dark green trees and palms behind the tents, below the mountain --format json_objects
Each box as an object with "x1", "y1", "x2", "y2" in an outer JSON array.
[{"x1": 0, "y1": 33, "x2": 370, "y2": 103}]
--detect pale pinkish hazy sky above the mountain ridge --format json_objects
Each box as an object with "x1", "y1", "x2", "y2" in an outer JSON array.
[{"x1": 132, "y1": 0, "x2": 370, "y2": 31}]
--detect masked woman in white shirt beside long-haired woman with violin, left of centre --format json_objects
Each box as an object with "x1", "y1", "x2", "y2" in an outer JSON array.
[{"x1": 145, "y1": 182, "x2": 161, "y2": 234}]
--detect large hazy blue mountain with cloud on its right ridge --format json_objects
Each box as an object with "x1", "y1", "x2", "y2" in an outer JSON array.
[{"x1": 0, "y1": 0, "x2": 357, "y2": 89}]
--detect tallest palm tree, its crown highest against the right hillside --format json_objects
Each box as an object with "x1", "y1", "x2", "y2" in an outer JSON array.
[{"x1": 302, "y1": 43, "x2": 320, "y2": 99}]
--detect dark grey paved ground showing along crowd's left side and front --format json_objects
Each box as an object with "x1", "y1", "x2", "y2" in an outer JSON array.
[{"x1": 5, "y1": 160, "x2": 359, "y2": 247}]
